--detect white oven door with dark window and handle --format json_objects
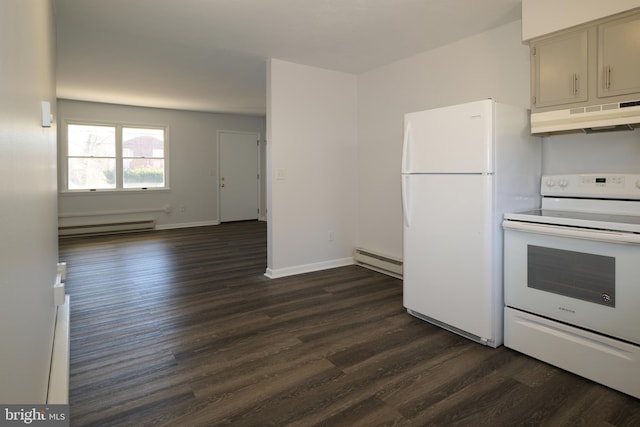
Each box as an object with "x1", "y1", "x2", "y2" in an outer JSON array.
[{"x1": 503, "y1": 220, "x2": 640, "y2": 344}]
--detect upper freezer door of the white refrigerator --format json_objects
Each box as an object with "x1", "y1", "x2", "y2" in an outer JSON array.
[{"x1": 402, "y1": 99, "x2": 495, "y2": 173}]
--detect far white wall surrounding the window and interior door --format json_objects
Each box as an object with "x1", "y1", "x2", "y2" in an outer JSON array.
[{"x1": 58, "y1": 100, "x2": 266, "y2": 228}]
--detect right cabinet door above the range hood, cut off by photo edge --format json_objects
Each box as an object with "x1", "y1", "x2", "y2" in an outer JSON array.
[{"x1": 598, "y1": 14, "x2": 640, "y2": 97}]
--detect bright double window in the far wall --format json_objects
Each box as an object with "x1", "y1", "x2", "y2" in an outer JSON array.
[{"x1": 66, "y1": 123, "x2": 168, "y2": 191}]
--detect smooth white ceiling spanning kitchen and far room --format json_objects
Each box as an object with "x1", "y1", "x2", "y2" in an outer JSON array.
[{"x1": 53, "y1": 0, "x2": 521, "y2": 115}]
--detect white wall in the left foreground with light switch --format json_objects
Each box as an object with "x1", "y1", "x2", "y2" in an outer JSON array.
[{"x1": 0, "y1": 0, "x2": 58, "y2": 404}]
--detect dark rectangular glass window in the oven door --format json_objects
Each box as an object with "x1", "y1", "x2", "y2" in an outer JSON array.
[{"x1": 527, "y1": 245, "x2": 616, "y2": 307}]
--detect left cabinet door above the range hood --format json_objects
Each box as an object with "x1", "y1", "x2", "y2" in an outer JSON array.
[{"x1": 531, "y1": 30, "x2": 589, "y2": 109}]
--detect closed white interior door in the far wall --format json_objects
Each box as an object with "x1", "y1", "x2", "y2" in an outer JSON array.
[{"x1": 218, "y1": 131, "x2": 260, "y2": 222}]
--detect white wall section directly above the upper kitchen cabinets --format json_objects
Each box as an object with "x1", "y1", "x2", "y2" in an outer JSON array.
[{"x1": 522, "y1": 0, "x2": 640, "y2": 40}]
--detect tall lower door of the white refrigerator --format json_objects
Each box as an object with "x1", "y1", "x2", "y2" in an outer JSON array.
[{"x1": 403, "y1": 174, "x2": 502, "y2": 346}]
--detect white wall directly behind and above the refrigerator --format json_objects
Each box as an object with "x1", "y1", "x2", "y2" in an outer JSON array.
[{"x1": 357, "y1": 21, "x2": 529, "y2": 257}]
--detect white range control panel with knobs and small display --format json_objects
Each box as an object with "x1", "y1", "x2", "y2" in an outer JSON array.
[{"x1": 540, "y1": 174, "x2": 640, "y2": 200}]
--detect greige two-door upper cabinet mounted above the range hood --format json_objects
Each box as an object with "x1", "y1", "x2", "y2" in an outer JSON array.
[{"x1": 530, "y1": 9, "x2": 640, "y2": 112}]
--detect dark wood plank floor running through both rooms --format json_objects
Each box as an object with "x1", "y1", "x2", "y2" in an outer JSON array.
[{"x1": 60, "y1": 222, "x2": 640, "y2": 426}]
